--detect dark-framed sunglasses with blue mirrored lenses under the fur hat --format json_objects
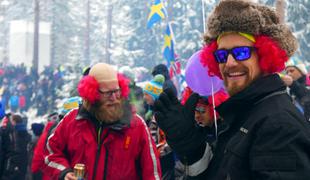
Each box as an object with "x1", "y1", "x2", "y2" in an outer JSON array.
[{"x1": 213, "y1": 46, "x2": 255, "y2": 63}]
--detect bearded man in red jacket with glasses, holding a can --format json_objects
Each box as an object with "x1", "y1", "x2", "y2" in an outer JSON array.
[{"x1": 45, "y1": 63, "x2": 161, "y2": 180}]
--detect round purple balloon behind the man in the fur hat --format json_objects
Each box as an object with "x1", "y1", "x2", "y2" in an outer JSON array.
[{"x1": 185, "y1": 51, "x2": 224, "y2": 96}]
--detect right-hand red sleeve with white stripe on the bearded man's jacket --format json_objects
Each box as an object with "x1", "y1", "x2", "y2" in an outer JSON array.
[{"x1": 136, "y1": 114, "x2": 162, "y2": 180}]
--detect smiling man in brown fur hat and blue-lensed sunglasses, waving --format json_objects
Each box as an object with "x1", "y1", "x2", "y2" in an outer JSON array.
[{"x1": 155, "y1": 0, "x2": 310, "y2": 180}]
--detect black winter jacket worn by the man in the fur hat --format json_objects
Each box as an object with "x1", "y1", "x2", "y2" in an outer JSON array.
[{"x1": 191, "y1": 75, "x2": 310, "y2": 180}]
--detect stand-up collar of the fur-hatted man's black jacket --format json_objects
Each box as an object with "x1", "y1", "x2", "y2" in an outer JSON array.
[{"x1": 216, "y1": 74, "x2": 286, "y2": 123}]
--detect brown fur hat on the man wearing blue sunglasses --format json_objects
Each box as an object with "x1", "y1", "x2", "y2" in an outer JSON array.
[{"x1": 204, "y1": 0, "x2": 298, "y2": 57}]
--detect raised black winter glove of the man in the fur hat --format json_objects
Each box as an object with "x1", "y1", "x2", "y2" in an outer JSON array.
[{"x1": 154, "y1": 89, "x2": 206, "y2": 157}]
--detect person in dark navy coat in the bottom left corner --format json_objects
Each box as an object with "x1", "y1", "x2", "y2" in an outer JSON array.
[{"x1": 0, "y1": 114, "x2": 31, "y2": 180}]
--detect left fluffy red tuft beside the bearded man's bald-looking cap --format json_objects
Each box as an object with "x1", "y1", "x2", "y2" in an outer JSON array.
[{"x1": 78, "y1": 75, "x2": 100, "y2": 104}]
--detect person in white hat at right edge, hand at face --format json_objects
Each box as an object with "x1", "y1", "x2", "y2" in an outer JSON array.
[{"x1": 281, "y1": 59, "x2": 310, "y2": 121}]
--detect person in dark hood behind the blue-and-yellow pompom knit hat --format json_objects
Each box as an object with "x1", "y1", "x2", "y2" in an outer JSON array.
[{"x1": 152, "y1": 64, "x2": 178, "y2": 96}]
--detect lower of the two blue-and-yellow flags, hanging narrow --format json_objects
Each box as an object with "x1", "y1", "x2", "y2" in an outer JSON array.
[{"x1": 163, "y1": 25, "x2": 175, "y2": 67}]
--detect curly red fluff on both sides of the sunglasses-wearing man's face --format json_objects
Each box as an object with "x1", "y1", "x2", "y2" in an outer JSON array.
[{"x1": 200, "y1": 35, "x2": 288, "y2": 79}]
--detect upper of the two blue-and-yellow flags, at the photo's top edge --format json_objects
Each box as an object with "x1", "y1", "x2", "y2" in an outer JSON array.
[{"x1": 147, "y1": 0, "x2": 166, "y2": 29}]
